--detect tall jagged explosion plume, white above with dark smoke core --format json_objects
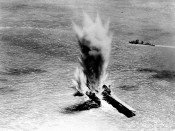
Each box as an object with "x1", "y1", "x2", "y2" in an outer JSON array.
[{"x1": 73, "y1": 13, "x2": 112, "y2": 94}]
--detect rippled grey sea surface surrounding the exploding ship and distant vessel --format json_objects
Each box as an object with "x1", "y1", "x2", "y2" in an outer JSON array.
[{"x1": 0, "y1": 0, "x2": 175, "y2": 131}]
